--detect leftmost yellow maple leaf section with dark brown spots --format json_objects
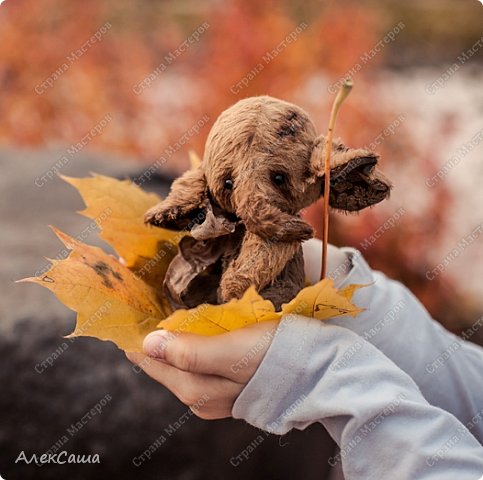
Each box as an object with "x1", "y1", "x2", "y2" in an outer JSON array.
[{"x1": 20, "y1": 228, "x2": 170, "y2": 351}]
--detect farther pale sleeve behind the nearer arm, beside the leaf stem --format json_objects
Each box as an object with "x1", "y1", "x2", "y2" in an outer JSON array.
[{"x1": 327, "y1": 248, "x2": 483, "y2": 444}]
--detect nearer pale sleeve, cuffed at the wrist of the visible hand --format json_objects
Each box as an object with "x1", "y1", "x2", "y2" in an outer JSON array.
[{"x1": 232, "y1": 315, "x2": 483, "y2": 480}]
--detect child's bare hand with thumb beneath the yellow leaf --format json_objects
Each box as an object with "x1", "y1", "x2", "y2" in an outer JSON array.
[{"x1": 126, "y1": 321, "x2": 278, "y2": 419}]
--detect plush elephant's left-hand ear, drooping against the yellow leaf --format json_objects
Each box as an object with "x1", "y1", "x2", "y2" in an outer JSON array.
[{"x1": 144, "y1": 168, "x2": 208, "y2": 230}]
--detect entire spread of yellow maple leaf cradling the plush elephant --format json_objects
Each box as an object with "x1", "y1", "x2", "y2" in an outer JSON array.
[{"x1": 19, "y1": 175, "x2": 362, "y2": 351}]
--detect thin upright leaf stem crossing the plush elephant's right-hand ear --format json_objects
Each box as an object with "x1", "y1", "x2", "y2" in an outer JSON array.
[{"x1": 320, "y1": 78, "x2": 353, "y2": 279}]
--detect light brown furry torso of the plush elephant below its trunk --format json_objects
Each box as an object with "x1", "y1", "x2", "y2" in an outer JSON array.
[{"x1": 218, "y1": 232, "x2": 303, "y2": 303}]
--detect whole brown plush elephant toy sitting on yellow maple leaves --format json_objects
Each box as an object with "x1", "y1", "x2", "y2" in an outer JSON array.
[{"x1": 145, "y1": 96, "x2": 390, "y2": 309}]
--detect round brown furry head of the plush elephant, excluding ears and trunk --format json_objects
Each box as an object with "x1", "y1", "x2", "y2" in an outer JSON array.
[{"x1": 203, "y1": 97, "x2": 320, "y2": 218}]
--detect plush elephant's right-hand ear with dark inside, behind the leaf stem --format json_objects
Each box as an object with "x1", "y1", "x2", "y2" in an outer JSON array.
[{"x1": 310, "y1": 135, "x2": 391, "y2": 212}]
